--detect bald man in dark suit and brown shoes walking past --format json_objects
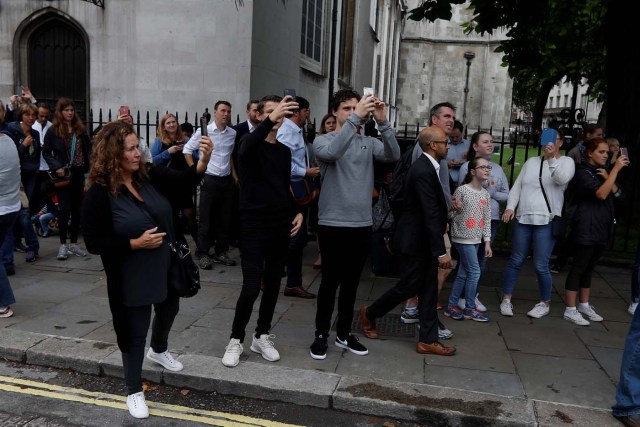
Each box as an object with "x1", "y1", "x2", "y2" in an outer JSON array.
[{"x1": 360, "y1": 126, "x2": 456, "y2": 356}]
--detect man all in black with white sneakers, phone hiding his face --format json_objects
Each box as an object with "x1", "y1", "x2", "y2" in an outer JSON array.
[{"x1": 222, "y1": 95, "x2": 302, "y2": 368}]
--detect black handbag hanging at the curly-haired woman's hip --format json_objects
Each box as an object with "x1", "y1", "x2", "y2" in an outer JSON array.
[{"x1": 167, "y1": 241, "x2": 200, "y2": 298}]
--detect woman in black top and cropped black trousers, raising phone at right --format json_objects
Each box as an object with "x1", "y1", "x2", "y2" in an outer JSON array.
[{"x1": 564, "y1": 137, "x2": 629, "y2": 326}]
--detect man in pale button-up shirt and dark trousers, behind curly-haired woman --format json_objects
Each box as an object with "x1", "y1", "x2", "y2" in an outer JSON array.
[{"x1": 182, "y1": 101, "x2": 238, "y2": 270}]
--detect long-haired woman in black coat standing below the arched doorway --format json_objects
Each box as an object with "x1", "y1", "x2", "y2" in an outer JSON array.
[{"x1": 42, "y1": 98, "x2": 91, "y2": 260}]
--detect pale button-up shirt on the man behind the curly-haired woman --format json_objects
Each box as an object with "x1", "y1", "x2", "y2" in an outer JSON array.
[{"x1": 182, "y1": 122, "x2": 236, "y2": 176}]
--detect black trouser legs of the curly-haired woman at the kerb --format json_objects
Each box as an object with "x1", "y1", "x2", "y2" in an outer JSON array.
[{"x1": 120, "y1": 296, "x2": 180, "y2": 394}]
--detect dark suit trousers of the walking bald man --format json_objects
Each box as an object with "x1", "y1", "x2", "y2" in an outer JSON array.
[{"x1": 368, "y1": 254, "x2": 438, "y2": 344}]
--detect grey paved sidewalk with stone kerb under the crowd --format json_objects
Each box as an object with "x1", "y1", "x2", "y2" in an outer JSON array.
[{"x1": 0, "y1": 236, "x2": 631, "y2": 426}]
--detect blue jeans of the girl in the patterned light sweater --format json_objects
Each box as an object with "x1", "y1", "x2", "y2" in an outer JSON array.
[{"x1": 449, "y1": 243, "x2": 484, "y2": 310}]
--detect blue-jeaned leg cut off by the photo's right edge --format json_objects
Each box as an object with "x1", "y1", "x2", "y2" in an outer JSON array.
[{"x1": 612, "y1": 304, "x2": 640, "y2": 417}]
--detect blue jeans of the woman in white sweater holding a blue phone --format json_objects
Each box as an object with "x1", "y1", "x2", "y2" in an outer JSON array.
[{"x1": 502, "y1": 219, "x2": 556, "y2": 301}]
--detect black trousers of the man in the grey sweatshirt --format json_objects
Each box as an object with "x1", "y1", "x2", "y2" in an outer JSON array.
[{"x1": 316, "y1": 225, "x2": 371, "y2": 339}]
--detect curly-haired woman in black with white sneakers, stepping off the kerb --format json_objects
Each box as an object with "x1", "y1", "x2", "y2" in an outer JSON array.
[{"x1": 82, "y1": 121, "x2": 213, "y2": 418}]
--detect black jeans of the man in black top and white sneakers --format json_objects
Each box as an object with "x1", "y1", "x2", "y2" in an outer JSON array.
[{"x1": 231, "y1": 218, "x2": 291, "y2": 342}]
